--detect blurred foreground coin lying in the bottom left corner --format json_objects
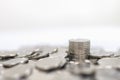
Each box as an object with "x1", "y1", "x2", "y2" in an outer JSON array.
[{"x1": 2, "y1": 64, "x2": 32, "y2": 80}]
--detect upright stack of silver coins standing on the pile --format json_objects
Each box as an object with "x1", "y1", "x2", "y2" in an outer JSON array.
[{"x1": 69, "y1": 39, "x2": 90, "y2": 62}]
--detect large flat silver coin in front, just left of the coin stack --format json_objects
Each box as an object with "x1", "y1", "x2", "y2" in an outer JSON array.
[{"x1": 36, "y1": 58, "x2": 66, "y2": 71}]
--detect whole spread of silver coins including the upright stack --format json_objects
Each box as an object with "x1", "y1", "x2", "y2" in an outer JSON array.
[{"x1": 0, "y1": 39, "x2": 120, "y2": 80}]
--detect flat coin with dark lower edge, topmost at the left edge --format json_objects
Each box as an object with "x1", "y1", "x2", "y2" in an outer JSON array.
[{"x1": 0, "y1": 51, "x2": 17, "y2": 59}]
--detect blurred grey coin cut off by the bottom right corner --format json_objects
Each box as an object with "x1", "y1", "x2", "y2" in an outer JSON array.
[{"x1": 96, "y1": 69, "x2": 120, "y2": 80}]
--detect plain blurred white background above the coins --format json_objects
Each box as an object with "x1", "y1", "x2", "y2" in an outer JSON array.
[{"x1": 0, "y1": 0, "x2": 120, "y2": 50}]
